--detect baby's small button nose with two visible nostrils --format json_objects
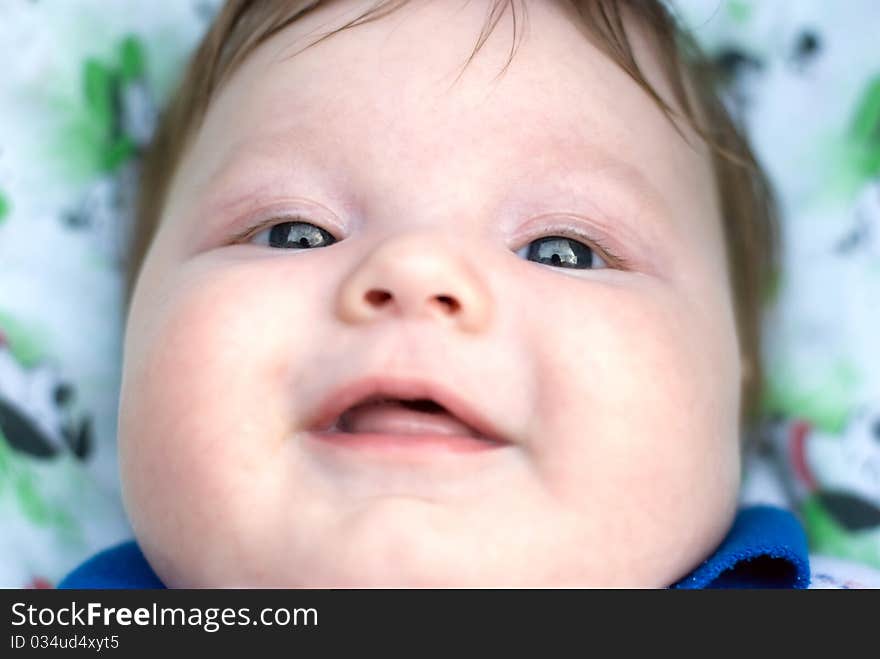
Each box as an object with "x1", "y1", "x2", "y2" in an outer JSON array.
[{"x1": 337, "y1": 232, "x2": 492, "y2": 332}]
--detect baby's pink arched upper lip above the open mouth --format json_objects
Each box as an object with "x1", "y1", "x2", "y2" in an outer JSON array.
[{"x1": 307, "y1": 376, "x2": 509, "y2": 444}]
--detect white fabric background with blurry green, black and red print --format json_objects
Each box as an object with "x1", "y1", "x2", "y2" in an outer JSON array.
[{"x1": 0, "y1": 0, "x2": 880, "y2": 588}]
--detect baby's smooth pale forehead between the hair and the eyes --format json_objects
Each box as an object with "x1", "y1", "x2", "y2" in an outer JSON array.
[{"x1": 174, "y1": 0, "x2": 714, "y2": 250}]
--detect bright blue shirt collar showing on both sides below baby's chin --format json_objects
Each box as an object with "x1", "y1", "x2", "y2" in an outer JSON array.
[{"x1": 58, "y1": 506, "x2": 810, "y2": 589}]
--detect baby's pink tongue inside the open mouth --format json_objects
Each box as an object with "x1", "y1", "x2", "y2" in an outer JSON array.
[{"x1": 339, "y1": 403, "x2": 479, "y2": 437}]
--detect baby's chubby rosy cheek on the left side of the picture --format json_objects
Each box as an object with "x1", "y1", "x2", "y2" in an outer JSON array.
[{"x1": 119, "y1": 260, "x2": 299, "y2": 583}]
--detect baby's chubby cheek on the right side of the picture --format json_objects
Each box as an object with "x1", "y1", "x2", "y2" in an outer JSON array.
[{"x1": 535, "y1": 280, "x2": 739, "y2": 564}]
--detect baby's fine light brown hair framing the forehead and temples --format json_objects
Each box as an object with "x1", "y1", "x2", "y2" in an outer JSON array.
[{"x1": 126, "y1": 0, "x2": 780, "y2": 434}]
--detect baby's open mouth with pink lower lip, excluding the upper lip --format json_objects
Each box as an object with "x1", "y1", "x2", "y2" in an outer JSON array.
[{"x1": 316, "y1": 398, "x2": 508, "y2": 453}]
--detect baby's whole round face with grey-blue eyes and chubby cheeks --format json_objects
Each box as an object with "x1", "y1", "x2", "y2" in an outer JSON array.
[{"x1": 120, "y1": 0, "x2": 742, "y2": 587}]
